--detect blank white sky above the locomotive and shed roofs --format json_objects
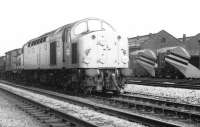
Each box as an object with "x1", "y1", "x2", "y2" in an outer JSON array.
[{"x1": 0, "y1": 0, "x2": 200, "y2": 56}]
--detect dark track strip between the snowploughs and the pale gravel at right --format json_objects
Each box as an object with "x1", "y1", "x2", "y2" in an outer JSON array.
[{"x1": 127, "y1": 78, "x2": 200, "y2": 90}]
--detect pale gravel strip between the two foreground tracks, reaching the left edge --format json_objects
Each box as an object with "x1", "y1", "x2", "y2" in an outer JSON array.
[{"x1": 0, "y1": 80, "x2": 144, "y2": 127}]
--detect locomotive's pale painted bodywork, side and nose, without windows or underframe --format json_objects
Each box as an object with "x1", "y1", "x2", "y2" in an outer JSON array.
[{"x1": 21, "y1": 18, "x2": 129, "y2": 70}]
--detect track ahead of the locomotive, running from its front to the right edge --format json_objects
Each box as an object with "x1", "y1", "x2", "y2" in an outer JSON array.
[{"x1": 117, "y1": 94, "x2": 200, "y2": 124}]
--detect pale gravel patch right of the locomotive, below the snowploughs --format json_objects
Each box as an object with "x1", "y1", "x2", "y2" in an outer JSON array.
[{"x1": 124, "y1": 79, "x2": 200, "y2": 105}]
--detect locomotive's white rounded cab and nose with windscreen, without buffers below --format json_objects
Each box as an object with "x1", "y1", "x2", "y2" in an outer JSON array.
[{"x1": 71, "y1": 19, "x2": 128, "y2": 68}]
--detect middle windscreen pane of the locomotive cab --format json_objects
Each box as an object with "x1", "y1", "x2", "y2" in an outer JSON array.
[{"x1": 88, "y1": 20, "x2": 101, "y2": 31}]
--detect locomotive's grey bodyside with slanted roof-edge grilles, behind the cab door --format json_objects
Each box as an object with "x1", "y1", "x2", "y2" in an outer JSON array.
[{"x1": 23, "y1": 33, "x2": 62, "y2": 70}]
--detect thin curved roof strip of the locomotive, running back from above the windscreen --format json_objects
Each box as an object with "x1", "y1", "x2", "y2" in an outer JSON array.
[{"x1": 24, "y1": 18, "x2": 107, "y2": 45}]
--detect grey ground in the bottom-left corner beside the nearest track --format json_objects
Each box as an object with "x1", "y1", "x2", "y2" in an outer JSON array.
[{"x1": 0, "y1": 90, "x2": 41, "y2": 127}]
